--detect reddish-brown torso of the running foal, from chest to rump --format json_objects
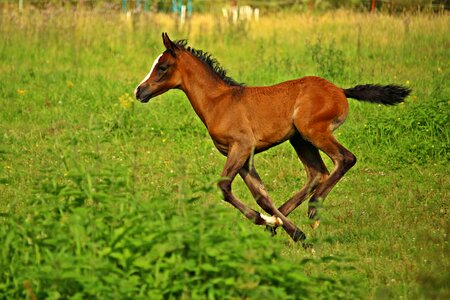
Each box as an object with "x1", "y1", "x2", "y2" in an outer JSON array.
[{"x1": 216, "y1": 76, "x2": 348, "y2": 152}]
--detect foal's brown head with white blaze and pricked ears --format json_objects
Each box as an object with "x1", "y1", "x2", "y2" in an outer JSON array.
[{"x1": 134, "y1": 32, "x2": 181, "y2": 103}]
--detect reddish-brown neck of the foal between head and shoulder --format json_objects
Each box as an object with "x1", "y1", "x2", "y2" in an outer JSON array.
[{"x1": 181, "y1": 59, "x2": 232, "y2": 126}]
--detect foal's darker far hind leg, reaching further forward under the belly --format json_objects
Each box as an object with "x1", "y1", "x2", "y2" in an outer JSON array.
[{"x1": 279, "y1": 134, "x2": 329, "y2": 216}]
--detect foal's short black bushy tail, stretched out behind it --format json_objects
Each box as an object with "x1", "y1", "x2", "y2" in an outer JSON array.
[{"x1": 343, "y1": 84, "x2": 411, "y2": 105}]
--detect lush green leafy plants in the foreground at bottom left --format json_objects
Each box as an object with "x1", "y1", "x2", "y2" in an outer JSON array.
[{"x1": 0, "y1": 163, "x2": 360, "y2": 299}]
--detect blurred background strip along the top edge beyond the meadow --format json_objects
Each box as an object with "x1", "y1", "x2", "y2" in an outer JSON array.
[{"x1": 0, "y1": 0, "x2": 450, "y2": 13}]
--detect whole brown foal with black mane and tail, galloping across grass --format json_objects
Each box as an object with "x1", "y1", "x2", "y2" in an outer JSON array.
[{"x1": 135, "y1": 33, "x2": 410, "y2": 241}]
